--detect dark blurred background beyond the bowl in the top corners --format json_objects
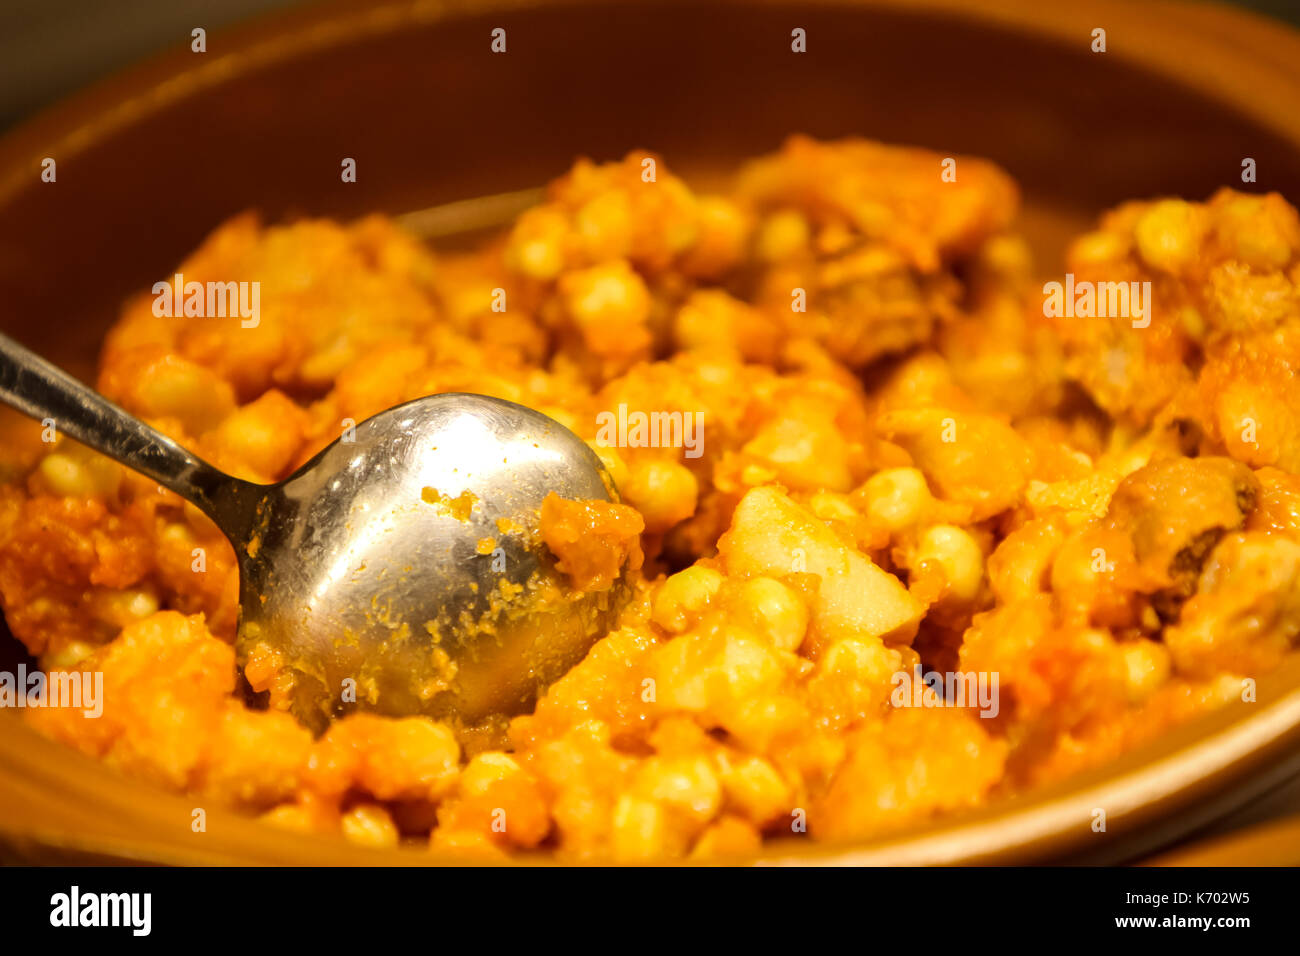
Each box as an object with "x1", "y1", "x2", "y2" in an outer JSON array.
[{"x1": 0, "y1": 0, "x2": 1300, "y2": 130}]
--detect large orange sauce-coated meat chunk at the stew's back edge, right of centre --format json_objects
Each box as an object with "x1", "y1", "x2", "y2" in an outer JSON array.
[{"x1": 737, "y1": 137, "x2": 1017, "y2": 367}]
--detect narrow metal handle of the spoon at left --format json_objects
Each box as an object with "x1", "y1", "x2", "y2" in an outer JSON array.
[{"x1": 0, "y1": 334, "x2": 257, "y2": 522}]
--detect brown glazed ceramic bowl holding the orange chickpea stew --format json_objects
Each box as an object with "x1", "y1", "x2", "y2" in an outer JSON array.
[{"x1": 0, "y1": 0, "x2": 1300, "y2": 864}]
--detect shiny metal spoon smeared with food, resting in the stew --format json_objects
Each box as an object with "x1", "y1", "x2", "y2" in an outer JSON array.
[{"x1": 0, "y1": 336, "x2": 627, "y2": 731}]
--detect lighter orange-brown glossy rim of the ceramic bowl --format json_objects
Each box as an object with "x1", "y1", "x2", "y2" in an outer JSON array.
[{"x1": 0, "y1": 0, "x2": 1300, "y2": 865}]
